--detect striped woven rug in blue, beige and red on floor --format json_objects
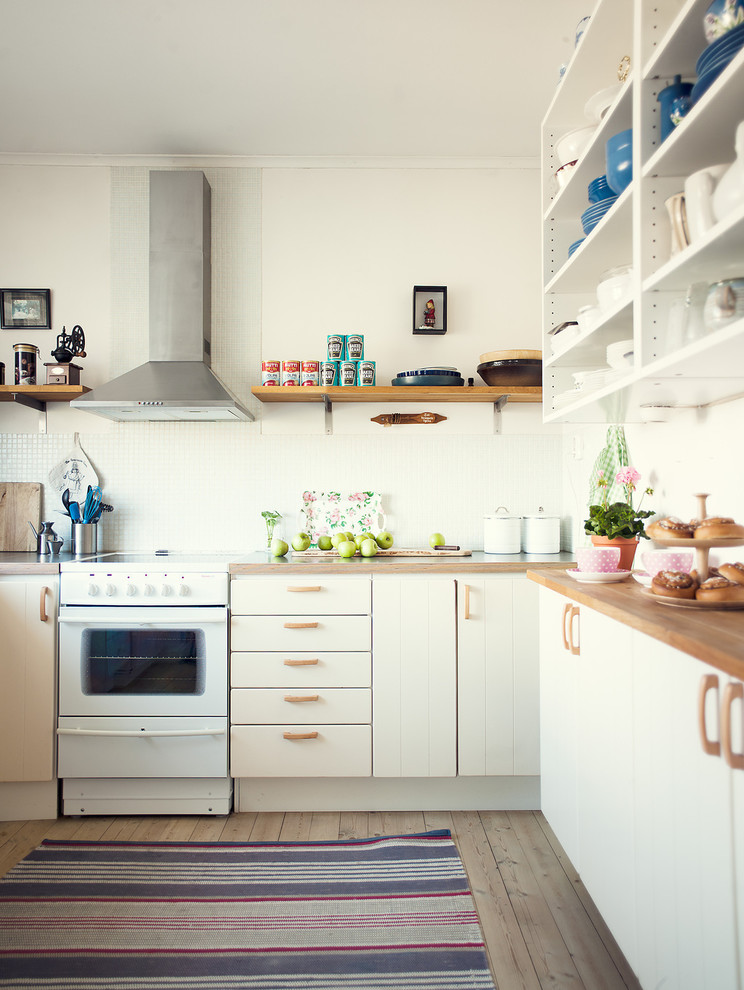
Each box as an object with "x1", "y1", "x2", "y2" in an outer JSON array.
[{"x1": 0, "y1": 830, "x2": 494, "y2": 990}]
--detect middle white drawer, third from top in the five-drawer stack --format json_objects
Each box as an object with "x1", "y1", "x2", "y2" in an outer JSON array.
[{"x1": 230, "y1": 651, "x2": 372, "y2": 688}]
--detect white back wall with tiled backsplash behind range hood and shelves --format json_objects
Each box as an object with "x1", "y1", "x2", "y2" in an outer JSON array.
[{"x1": 0, "y1": 161, "x2": 562, "y2": 552}]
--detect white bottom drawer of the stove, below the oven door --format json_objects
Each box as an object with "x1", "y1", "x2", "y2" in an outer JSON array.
[{"x1": 58, "y1": 716, "x2": 227, "y2": 777}]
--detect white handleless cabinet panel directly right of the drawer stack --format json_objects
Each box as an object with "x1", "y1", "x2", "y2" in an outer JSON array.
[{"x1": 372, "y1": 575, "x2": 457, "y2": 777}]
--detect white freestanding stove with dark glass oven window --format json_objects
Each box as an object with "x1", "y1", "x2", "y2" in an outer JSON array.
[{"x1": 57, "y1": 557, "x2": 232, "y2": 814}]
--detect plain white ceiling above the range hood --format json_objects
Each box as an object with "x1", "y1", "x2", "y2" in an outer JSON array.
[{"x1": 0, "y1": 0, "x2": 592, "y2": 158}]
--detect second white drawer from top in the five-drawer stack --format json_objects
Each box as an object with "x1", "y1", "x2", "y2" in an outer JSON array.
[{"x1": 230, "y1": 613, "x2": 372, "y2": 652}]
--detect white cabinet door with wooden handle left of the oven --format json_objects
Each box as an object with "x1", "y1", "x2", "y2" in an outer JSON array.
[{"x1": 0, "y1": 574, "x2": 58, "y2": 788}]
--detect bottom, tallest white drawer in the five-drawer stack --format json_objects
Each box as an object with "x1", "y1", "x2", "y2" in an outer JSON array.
[{"x1": 230, "y1": 725, "x2": 372, "y2": 777}]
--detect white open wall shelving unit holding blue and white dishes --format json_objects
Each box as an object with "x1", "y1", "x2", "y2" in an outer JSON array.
[{"x1": 542, "y1": 0, "x2": 744, "y2": 422}]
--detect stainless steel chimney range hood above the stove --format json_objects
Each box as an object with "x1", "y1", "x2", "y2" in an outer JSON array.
[{"x1": 70, "y1": 171, "x2": 253, "y2": 422}]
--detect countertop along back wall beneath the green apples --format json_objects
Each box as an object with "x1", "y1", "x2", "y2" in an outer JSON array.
[{"x1": 230, "y1": 550, "x2": 575, "y2": 575}]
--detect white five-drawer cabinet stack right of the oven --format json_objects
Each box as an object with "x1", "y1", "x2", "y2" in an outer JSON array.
[{"x1": 230, "y1": 576, "x2": 372, "y2": 778}]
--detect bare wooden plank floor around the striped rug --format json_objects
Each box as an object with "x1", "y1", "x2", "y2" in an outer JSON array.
[{"x1": 0, "y1": 811, "x2": 640, "y2": 990}]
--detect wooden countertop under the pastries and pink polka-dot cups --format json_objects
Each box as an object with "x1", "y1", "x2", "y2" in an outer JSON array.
[{"x1": 527, "y1": 568, "x2": 744, "y2": 680}]
